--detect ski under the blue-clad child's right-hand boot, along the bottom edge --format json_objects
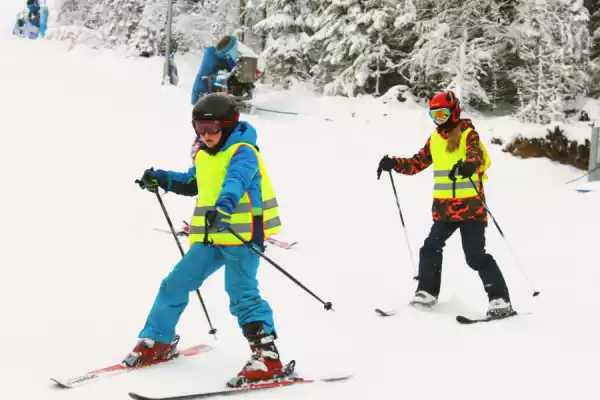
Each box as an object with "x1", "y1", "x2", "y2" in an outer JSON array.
[{"x1": 129, "y1": 375, "x2": 352, "y2": 400}]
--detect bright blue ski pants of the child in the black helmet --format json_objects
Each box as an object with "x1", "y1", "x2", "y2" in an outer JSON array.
[{"x1": 139, "y1": 243, "x2": 275, "y2": 343}]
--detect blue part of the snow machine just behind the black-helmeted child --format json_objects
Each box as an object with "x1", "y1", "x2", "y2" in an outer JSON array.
[{"x1": 192, "y1": 38, "x2": 240, "y2": 105}]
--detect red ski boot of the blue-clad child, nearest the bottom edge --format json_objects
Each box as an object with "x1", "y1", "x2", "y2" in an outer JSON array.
[{"x1": 227, "y1": 322, "x2": 293, "y2": 387}]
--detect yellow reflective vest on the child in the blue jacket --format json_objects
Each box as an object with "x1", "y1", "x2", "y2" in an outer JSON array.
[{"x1": 189, "y1": 143, "x2": 281, "y2": 246}]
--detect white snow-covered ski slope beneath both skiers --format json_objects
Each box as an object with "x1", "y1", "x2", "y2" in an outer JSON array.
[{"x1": 0, "y1": 0, "x2": 600, "y2": 400}]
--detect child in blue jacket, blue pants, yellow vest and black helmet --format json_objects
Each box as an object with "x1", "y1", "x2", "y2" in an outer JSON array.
[{"x1": 124, "y1": 94, "x2": 284, "y2": 386}]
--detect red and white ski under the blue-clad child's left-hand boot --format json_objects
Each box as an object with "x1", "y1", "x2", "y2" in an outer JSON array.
[{"x1": 50, "y1": 344, "x2": 212, "y2": 389}]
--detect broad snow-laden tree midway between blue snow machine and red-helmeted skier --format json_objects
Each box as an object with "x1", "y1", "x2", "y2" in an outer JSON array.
[{"x1": 305, "y1": 0, "x2": 396, "y2": 96}]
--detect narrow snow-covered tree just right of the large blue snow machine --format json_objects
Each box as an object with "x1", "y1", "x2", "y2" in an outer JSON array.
[{"x1": 253, "y1": 0, "x2": 314, "y2": 88}]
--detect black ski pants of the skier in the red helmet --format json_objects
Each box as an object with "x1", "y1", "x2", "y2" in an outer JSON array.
[{"x1": 417, "y1": 220, "x2": 510, "y2": 301}]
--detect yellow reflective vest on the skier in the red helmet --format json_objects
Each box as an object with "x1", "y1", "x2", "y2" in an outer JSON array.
[{"x1": 429, "y1": 128, "x2": 490, "y2": 199}]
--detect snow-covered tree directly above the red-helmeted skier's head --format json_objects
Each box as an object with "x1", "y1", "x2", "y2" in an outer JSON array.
[{"x1": 396, "y1": 0, "x2": 505, "y2": 104}]
